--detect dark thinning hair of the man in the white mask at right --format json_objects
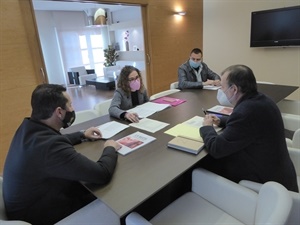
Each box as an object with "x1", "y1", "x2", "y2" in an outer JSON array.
[{"x1": 221, "y1": 65, "x2": 257, "y2": 93}]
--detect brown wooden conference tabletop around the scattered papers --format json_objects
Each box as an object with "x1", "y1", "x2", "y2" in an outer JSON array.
[{"x1": 63, "y1": 84, "x2": 298, "y2": 221}]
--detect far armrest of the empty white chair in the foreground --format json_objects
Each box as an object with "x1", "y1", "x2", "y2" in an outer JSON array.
[{"x1": 192, "y1": 168, "x2": 258, "y2": 224}]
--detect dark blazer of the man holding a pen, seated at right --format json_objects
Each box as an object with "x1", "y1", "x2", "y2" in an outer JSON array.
[{"x1": 200, "y1": 93, "x2": 298, "y2": 191}]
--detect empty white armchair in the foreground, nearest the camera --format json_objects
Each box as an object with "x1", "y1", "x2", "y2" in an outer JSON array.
[{"x1": 126, "y1": 168, "x2": 292, "y2": 225}]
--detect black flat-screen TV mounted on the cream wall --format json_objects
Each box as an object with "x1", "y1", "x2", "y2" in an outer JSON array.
[{"x1": 250, "y1": 6, "x2": 300, "y2": 47}]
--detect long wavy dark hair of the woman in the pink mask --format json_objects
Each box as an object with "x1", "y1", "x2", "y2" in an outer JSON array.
[{"x1": 118, "y1": 66, "x2": 145, "y2": 95}]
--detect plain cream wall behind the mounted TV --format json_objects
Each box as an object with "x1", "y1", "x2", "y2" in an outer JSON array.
[{"x1": 203, "y1": 0, "x2": 300, "y2": 100}]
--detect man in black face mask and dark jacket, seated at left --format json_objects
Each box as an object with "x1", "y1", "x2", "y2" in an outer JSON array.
[{"x1": 3, "y1": 84, "x2": 120, "y2": 225}]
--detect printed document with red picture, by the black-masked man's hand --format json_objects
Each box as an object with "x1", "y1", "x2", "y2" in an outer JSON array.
[{"x1": 117, "y1": 131, "x2": 156, "y2": 155}]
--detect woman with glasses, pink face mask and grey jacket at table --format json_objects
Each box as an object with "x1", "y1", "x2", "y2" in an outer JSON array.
[{"x1": 109, "y1": 66, "x2": 149, "y2": 123}]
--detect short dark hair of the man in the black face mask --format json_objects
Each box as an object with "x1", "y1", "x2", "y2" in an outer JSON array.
[{"x1": 31, "y1": 84, "x2": 68, "y2": 120}]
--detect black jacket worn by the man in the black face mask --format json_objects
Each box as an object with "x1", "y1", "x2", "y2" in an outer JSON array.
[{"x1": 3, "y1": 118, "x2": 117, "y2": 224}]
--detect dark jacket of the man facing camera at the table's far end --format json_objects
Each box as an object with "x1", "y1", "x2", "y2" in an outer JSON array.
[{"x1": 178, "y1": 61, "x2": 221, "y2": 89}]
